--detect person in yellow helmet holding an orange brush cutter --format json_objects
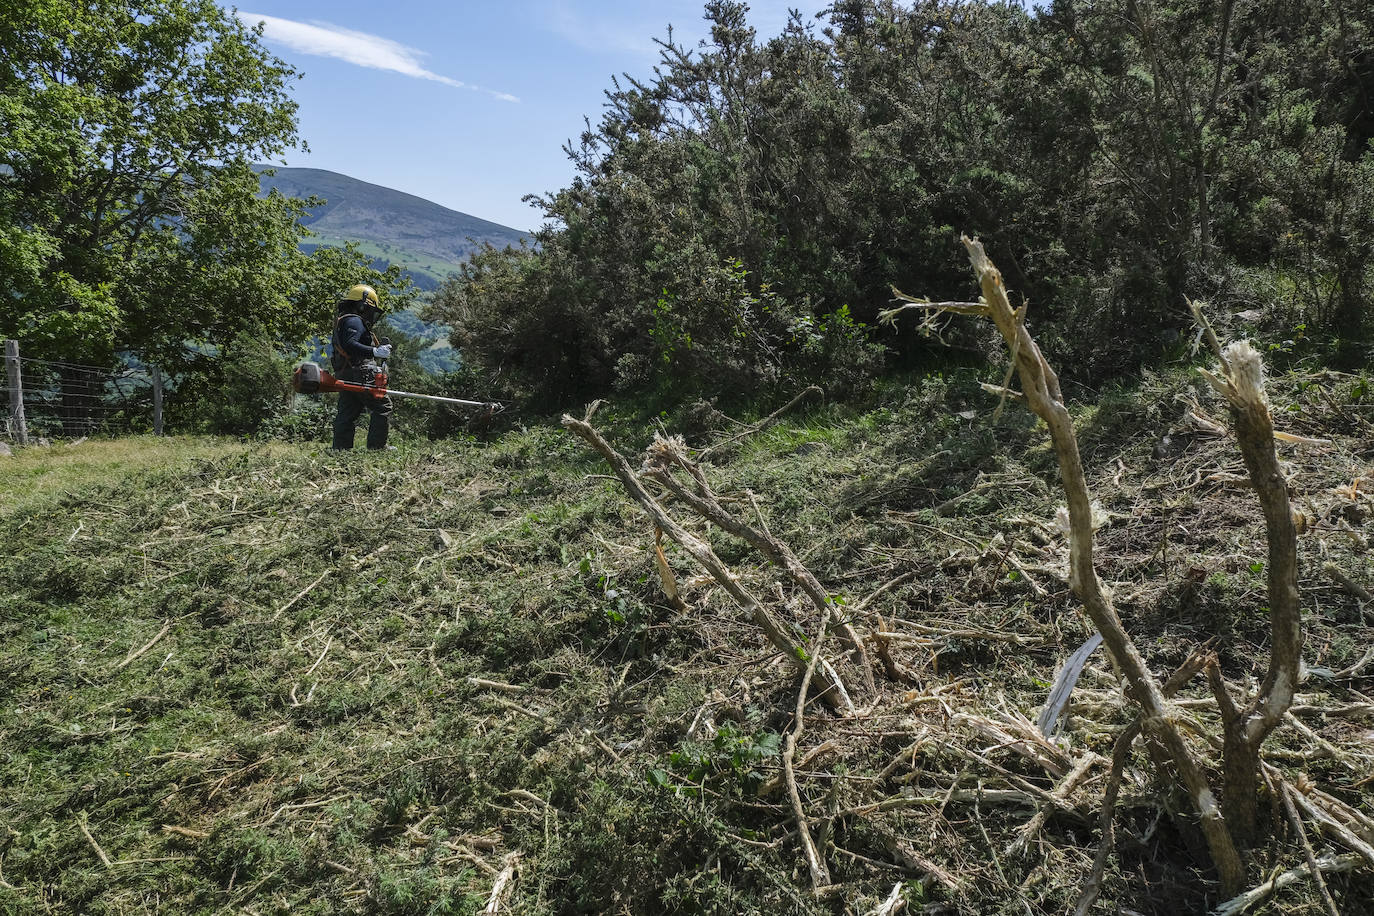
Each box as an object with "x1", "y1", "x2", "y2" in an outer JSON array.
[{"x1": 291, "y1": 284, "x2": 503, "y2": 450}]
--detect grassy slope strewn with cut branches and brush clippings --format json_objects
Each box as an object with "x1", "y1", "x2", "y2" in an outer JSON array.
[{"x1": 0, "y1": 371, "x2": 1374, "y2": 916}]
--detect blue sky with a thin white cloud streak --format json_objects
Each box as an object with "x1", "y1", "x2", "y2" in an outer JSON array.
[{"x1": 239, "y1": 0, "x2": 807, "y2": 229}]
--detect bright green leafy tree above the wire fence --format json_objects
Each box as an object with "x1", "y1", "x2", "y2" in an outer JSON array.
[{"x1": 0, "y1": 0, "x2": 396, "y2": 368}]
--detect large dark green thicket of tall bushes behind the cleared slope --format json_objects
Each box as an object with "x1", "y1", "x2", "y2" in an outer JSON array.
[{"x1": 436, "y1": 0, "x2": 1374, "y2": 401}]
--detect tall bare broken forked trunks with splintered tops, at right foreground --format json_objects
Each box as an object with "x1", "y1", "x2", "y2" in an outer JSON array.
[{"x1": 883, "y1": 239, "x2": 1374, "y2": 913}]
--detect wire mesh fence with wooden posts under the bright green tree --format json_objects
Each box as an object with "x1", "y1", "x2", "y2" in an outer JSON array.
[{"x1": 4, "y1": 347, "x2": 155, "y2": 442}]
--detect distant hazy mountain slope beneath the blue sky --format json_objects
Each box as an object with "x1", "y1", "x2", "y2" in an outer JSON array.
[{"x1": 256, "y1": 165, "x2": 529, "y2": 290}]
